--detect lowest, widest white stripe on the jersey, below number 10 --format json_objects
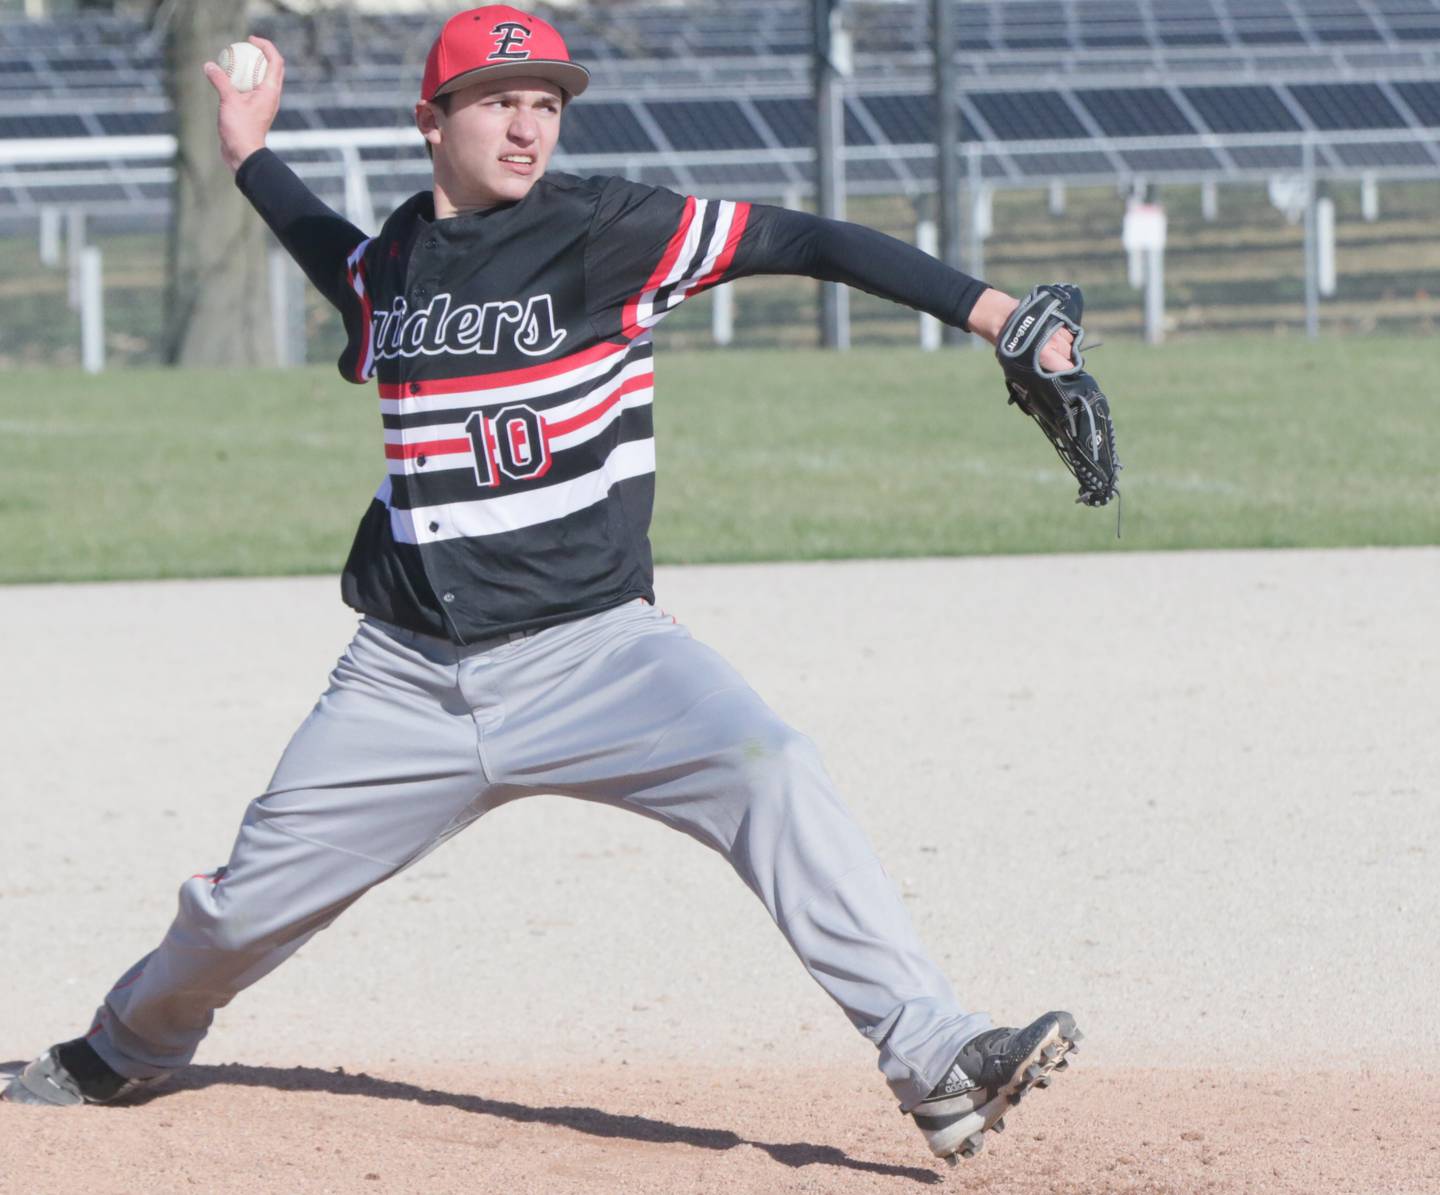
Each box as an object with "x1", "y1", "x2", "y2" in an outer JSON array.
[{"x1": 390, "y1": 439, "x2": 655, "y2": 544}]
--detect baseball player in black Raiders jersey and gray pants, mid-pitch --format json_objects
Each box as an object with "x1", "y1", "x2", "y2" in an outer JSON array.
[{"x1": 6, "y1": 6, "x2": 1080, "y2": 1162}]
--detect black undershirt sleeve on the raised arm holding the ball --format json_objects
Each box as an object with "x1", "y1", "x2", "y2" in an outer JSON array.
[{"x1": 235, "y1": 150, "x2": 366, "y2": 312}]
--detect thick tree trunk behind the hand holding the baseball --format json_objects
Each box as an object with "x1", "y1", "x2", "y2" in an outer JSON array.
[{"x1": 164, "y1": 0, "x2": 275, "y2": 366}]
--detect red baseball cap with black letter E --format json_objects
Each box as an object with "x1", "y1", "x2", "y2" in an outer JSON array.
[{"x1": 420, "y1": 4, "x2": 590, "y2": 101}]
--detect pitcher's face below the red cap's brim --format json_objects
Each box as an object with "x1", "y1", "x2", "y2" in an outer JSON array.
[{"x1": 422, "y1": 76, "x2": 564, "y2": 209}]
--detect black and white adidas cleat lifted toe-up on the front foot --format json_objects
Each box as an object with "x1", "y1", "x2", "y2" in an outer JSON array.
[{"x1": 910, "y1": 1012, "x2": 1083, "y2": 1166}]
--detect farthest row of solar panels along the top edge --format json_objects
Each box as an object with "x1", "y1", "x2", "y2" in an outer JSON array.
[{"x1": 0, "y1": 0, "x2": 1440, "y2": 83}]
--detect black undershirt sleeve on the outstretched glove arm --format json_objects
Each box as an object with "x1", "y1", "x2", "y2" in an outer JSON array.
[{"x1": 726, "y1": 203, "x2": 988, "y2": 328}]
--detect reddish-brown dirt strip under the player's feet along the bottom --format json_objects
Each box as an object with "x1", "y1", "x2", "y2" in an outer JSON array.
[{"x1": 0, "y1": 1064, "x2": 1440, "y2": 1195}]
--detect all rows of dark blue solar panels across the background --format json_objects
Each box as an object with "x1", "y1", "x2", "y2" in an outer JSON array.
[{"x1": 0, "y1": 0, "x2": 1440, "y2": 226}]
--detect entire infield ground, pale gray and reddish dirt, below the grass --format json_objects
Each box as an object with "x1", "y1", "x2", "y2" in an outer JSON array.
[{"x1": 0, "y1": 550, "x2": 1440, "y2": 1195}]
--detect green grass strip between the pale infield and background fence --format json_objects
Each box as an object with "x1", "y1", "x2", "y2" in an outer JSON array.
[{"x1": 0, "y1": 337, "x2": 1440, "y2": 582}]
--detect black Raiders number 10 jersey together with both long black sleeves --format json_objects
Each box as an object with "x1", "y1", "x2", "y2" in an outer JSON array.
[{"x1": 238, "y1": 150, "x2": 985, "y2": 644}]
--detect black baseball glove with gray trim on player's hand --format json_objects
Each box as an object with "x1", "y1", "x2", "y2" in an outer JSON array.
[{"x1": 995, "y1": 282, "x2": 1120, "y2": 507}]
